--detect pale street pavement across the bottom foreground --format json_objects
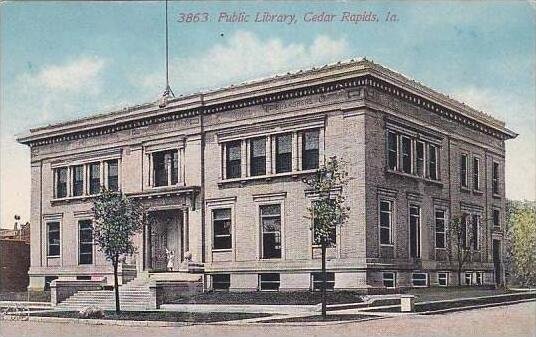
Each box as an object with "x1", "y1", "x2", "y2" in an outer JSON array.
[{"x1": 0, "y1": 302, "x2": 536, "y2": 337}]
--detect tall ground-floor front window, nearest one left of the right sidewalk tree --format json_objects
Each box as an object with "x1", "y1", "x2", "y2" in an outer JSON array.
[{"x1": 260, "y1": 205, "x2": 281, "y2": 258}]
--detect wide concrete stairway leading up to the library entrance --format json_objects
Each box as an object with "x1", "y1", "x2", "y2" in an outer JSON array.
[{"x1": 57, "y1": 275, "x2": 156, "y2": 310}]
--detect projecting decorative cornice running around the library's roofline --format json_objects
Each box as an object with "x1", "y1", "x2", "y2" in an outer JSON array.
[{"x1": 18, "y1": 60, "x2": 517, "y2": 146}]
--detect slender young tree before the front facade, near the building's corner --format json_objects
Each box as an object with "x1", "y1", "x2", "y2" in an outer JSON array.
[{"x1": 303, "y1": 157, "x2": 350, "y2": 317}]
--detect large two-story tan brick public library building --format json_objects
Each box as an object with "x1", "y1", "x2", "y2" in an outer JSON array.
[{"x1": 19, "y1": 59, "x2": 516, "y2": 290}]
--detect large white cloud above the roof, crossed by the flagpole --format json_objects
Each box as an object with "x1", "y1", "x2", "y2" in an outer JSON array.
[{"x1": 136, "y1": 31, "x2": 348, "y2": 94}]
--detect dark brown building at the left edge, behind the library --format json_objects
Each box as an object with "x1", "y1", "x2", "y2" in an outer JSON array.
[{"x1": 0, "y1": 223, "x2": 30, "y2": 291}]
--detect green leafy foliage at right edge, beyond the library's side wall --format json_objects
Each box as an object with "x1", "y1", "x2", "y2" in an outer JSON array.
[{"x1": 504, "y1": 200, "x2": 536, "y2": 286}]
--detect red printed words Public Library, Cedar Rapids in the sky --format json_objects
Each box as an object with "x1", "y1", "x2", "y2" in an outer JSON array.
[{"x1": 218, "y1": 11, "x2": 386, "y2": 25}]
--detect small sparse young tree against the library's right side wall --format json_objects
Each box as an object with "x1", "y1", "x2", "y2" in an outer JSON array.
[{"x1": 447, "y1": 215, "x2": 478, "y2": 286}]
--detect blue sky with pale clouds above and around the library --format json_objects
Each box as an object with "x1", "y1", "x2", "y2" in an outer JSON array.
[{"x1": 0, "y1": 1, "x2": 536, "y2": 227}]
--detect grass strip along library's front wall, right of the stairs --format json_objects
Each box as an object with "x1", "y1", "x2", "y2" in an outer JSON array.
[{"x1": 172, "y1": 291, "x2": 363, "y2": 305}]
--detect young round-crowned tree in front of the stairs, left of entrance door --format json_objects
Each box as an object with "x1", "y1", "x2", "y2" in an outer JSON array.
[{"x1": 93, "y1": 189, "x2": 147, "y2": 313}]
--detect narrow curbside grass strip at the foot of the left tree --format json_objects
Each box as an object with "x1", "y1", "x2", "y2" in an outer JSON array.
[{"x1": 31, "y1": 311, "x2": 270, "y2": 323}]
